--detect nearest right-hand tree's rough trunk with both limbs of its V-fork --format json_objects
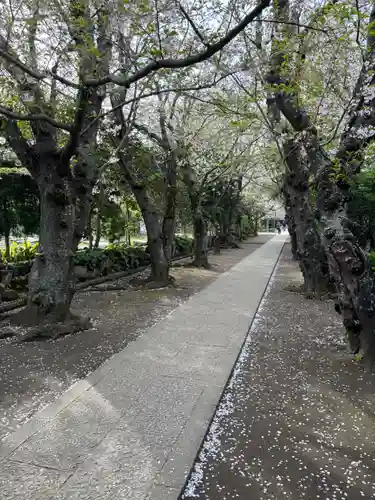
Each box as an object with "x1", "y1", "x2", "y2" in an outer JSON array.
[{"x1": 267, "y1": 0, "x2": 375, "y2": 369}]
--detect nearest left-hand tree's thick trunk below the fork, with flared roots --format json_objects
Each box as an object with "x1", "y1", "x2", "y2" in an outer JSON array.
[{"x1": 12, "y1": 162, "x2": 90, "y2": 340}]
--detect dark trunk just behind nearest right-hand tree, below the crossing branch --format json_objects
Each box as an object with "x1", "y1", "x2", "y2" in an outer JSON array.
[{"x1": 283, "y1": 139, "x2": 330, "y2": 298}]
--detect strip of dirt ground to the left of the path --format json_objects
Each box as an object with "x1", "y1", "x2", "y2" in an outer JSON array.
[{"x1": 0, "y1": 235, "x2": 271, "y2": 439}]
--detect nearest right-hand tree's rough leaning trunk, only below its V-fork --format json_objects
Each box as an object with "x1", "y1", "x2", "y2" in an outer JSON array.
[{"x1": 317, "y1": 162, "x2": 375, "y2": 364}]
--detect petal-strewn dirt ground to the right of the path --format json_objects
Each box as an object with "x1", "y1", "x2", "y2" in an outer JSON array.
[{"x1": 182, "y1": 246, "x2": 375, "y2": 500}]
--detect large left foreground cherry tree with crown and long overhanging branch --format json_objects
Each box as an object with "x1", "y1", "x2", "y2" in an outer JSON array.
[{"x1": 0, "y1": 0, "x2": 270, "y2": 331}]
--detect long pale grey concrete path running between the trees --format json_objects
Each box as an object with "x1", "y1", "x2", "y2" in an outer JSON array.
[{"x1": 0, "y1": 234, "x2": 286, "y2": 500}]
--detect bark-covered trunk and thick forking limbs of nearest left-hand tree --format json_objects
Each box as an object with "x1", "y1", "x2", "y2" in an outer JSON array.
[{"x1": 4, "y1": 3, "x2": 111, "y2": 331}]
